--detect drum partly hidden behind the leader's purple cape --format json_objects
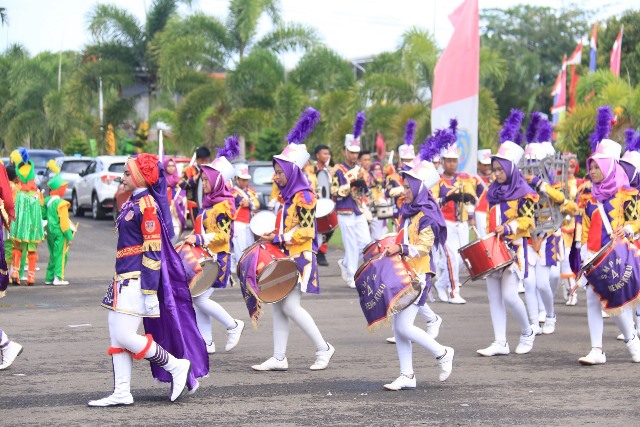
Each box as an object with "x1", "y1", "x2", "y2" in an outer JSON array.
[{"x1": 175, "y1": 243, "x2": 220, "y2": 297}]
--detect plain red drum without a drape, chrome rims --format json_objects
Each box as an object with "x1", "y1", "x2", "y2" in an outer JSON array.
[{"x1": 458, "y1": 233, "x2": 515, "y2": 280}]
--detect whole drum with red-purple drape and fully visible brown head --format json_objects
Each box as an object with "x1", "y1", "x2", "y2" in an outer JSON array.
[{"x1": 238, "y1": 242, "x2": 298, "y2": 303}]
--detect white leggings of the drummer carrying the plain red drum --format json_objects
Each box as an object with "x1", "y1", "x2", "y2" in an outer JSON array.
[{"x1": 487, "y1": 268, "x2": 531, "y2": 344}]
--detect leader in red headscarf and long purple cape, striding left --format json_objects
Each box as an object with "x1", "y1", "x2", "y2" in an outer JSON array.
[{"x1": 89, "y1": 153, "x2": 209, "y2": 406}]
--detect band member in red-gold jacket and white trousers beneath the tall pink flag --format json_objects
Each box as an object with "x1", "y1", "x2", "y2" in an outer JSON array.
[{"x1": 431, "y1": 121, "x2": 484, "y2": 304}]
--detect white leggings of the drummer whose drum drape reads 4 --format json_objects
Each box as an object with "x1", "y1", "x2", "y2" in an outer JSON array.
[{"x1": 393, "y1": 304, "x2": 445, "y2": 375}]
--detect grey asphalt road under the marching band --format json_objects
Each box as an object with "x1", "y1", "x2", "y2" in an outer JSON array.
[{"x1": 0, "y1": 218, "x2": 640, "y2": 426}]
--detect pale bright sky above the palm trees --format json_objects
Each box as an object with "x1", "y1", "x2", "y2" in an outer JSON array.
[{"x1": 0, "y1": 0, "x2": 638, "y2": 66}]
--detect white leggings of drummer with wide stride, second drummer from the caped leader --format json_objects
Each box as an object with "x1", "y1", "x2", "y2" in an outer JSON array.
[{"x1": 271, "y1": 286, "x2": 328, "y2": 360}]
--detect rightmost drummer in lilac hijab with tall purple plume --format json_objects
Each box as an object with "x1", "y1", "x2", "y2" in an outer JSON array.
[{"x1": 578, "y1": 106, "x2": 640, "y2": 365}]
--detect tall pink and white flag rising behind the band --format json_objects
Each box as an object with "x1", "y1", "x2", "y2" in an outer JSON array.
[{"x1": 431, "y1": 0, "x2": 480, "y2": 175}]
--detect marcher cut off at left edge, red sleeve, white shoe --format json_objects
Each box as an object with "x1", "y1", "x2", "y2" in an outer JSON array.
[{"x1": 0, "y1": 164, "x2": 22, "y2": 371}]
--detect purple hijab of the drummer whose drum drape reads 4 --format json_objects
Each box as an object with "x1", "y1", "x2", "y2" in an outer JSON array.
[{"x1": 400, "y1": 174, "x2": 447, "y2": 245}]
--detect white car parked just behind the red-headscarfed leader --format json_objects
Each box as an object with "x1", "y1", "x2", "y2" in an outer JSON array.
[{"x1": 71, "y1": 156, "x2": 128, "y2": 219}]
